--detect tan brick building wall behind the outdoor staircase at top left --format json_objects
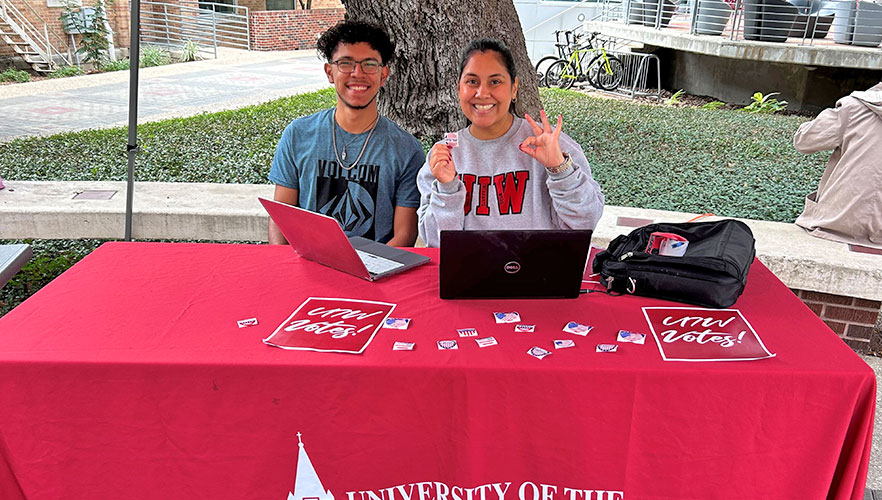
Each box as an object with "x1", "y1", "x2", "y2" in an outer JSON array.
[{"x1": 0, "y1": 0, "x2": 130, "y2": 56}]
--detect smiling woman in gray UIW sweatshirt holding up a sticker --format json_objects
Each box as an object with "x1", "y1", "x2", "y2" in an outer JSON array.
[{"x1": 417, "y1": 38, "x2": 604, "y2": 247}]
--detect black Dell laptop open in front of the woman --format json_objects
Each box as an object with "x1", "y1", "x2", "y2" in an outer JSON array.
[{"x1": 440, "y1": 230, "x2": 591, "y2": 299}]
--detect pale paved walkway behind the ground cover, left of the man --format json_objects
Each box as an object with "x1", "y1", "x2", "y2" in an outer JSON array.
[{"x1": 0, "y1": 48, "x2": 329, "y2": 142}]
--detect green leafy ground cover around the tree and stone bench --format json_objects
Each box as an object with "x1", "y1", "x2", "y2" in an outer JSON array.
[{"x1": 0, "y1": 85, "x2": 829, "y2": 314}]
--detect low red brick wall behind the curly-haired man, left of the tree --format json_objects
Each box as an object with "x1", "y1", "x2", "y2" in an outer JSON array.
[{"x1": 251, "y1": 9, "x2": 346, "y2": 50}]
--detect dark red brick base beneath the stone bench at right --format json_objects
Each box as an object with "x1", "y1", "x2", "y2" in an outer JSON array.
[{"x1": 793, "y1": 290, "x2": 882, "y2": 354}]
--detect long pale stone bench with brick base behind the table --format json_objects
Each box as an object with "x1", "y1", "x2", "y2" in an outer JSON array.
[{"x1": 0, "y1": 181, "x2": 882, "y2": 352}]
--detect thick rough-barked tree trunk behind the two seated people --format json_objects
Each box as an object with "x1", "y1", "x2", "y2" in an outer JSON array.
[{"x1": 343, "y1": 0, "x2": 541, "y2": 139}]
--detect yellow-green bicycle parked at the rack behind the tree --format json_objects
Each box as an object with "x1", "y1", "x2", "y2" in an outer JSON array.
[{"x1": 544, "y1": 32, "x2": 625, "y2": 91}]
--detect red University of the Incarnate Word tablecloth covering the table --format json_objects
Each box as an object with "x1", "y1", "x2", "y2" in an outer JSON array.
[{"x1": 0, "y1": 243, "x2": 875, "y2": 500}]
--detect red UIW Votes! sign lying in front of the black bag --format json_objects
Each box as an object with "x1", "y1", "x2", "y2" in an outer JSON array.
[{"x1": 643, "y1": 307, "x2": 775, "y2": 361}]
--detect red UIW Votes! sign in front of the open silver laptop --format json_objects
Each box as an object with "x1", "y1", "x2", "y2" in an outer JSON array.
[{"x1": 263, "y1": 297, "x2": 395, "y2": 354}]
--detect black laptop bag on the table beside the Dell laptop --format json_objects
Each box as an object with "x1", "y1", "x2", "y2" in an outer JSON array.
[{"x1": 593, "y1": 219, "x2": 756, "y2": 307}]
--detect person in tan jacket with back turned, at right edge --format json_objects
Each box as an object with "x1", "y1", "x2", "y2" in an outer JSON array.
[{"x1": 793, "y1": 83, "x2": 882, "y2": 249}]
